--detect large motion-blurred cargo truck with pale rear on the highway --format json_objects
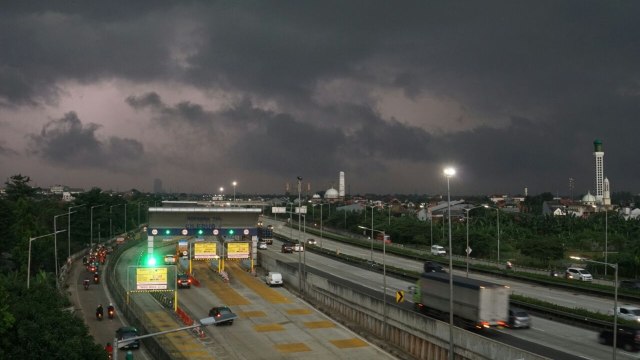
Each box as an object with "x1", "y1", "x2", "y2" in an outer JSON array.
[{"x1": 413, "y1": 272, "x2": 509, "y2": 329}]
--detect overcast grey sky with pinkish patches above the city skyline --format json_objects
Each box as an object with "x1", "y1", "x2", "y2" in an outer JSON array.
[{"x1": 0, "y1": 0, "x2": 640, "y2": 195}]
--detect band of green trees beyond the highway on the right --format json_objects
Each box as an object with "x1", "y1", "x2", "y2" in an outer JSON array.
[{"x1": 307, "y1": 198, "x2": 640, "y2": 278}]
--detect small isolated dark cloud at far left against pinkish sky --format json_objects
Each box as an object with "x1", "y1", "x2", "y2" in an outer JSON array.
[{"x1": 30, "y1": 112, "x2": 146, "y2": 172}]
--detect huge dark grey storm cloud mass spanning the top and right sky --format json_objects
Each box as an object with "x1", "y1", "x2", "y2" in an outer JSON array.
[{"x1": 0, "y1": 1, "x2": 640, "y2": 191}]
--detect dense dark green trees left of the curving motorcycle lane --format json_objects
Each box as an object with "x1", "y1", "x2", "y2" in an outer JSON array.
[{"x1": 0, "y1": 175, "x2": 161, "y2": 359}]
